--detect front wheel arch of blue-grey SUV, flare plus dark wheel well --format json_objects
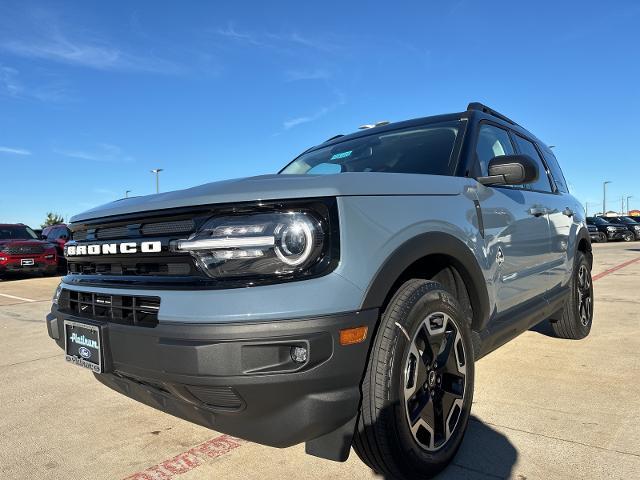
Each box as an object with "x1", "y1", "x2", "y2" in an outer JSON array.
[{"x1": 362, "y1": 232, "x2": 491, "y2": 331}]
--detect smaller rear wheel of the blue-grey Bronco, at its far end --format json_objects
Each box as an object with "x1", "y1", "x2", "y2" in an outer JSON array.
[{"x1": 551, "y1": 251, "x2": 593, "y2": 340}]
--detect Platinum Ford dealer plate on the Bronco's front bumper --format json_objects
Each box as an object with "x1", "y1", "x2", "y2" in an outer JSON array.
[{"x1": 64, "y1": 320, "x2": 104, "y2": 373}]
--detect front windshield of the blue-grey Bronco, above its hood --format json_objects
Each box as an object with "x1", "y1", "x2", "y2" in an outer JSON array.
[{"x1": 280, "y1": 121, "x2": 461, "y2": 175}]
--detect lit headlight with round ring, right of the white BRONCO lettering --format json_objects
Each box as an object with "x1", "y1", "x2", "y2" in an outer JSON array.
[{"x1": 172, "y1": 203, "x2": 338, "y2": 284}]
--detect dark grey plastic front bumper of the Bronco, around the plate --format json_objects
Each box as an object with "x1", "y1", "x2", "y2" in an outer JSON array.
[{"x1": 47, "y1": 305, "x2": 378, "y2": 447}]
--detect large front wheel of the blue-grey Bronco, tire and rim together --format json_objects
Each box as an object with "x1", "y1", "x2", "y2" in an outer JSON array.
[{"x1": 354, "y1": 279, "x2": 474, "y2": 479}]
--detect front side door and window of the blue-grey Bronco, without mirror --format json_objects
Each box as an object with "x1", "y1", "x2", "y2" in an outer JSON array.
[{"x1": 475, "y1": 122, "x2": 551, "y2": 314}]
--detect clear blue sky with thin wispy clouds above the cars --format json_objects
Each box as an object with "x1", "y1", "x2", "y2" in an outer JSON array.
[{"x1": 0, "y1": 0, "x2": 640, "y2": 227}]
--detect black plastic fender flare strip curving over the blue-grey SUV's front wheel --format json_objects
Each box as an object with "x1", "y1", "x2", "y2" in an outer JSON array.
[{"x1": 362, "y1": 232, "x2": 491, "y2": 331}]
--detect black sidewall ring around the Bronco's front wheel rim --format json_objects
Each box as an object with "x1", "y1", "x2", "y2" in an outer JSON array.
[{"x1": 385, "y1": 284, "x2": 474, "y2": 475}]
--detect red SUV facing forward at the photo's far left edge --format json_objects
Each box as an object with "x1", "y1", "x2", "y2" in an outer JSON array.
[{"x1": 0, "y1": 224, "x2": 58, "y2": 276}]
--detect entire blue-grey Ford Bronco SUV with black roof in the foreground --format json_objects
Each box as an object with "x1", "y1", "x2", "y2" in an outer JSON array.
[{"x1": 47, "y1": 103, "x2": 593, "y2": 478}]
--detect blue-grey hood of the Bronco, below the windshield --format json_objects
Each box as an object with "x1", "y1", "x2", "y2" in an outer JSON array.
[{"x1": 71, "y1": 172, "x2": 469, "y2": 222}]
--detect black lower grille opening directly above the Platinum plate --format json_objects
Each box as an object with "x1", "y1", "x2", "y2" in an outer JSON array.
[{"x1": 58, "y1": 289, "x2": 160, "y2": 327}]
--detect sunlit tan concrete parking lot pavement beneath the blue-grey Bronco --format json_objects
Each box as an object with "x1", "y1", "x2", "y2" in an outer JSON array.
[{"x1": 0, "y1": 242, "x2": 640, "y2": 480}]
